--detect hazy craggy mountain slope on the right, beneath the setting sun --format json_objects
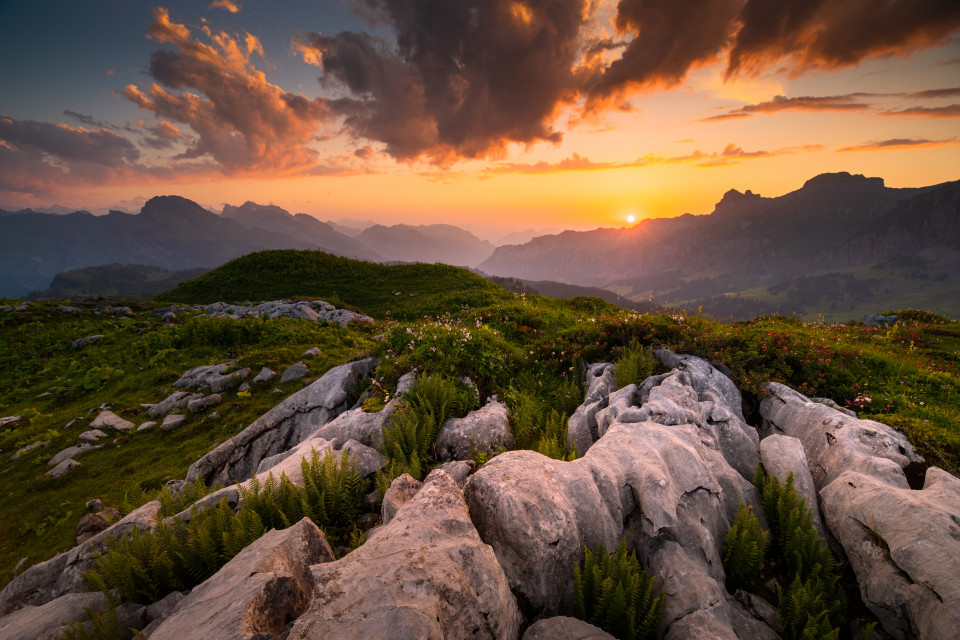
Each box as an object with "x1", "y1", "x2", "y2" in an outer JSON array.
[{"x1": 479, "y1": 173, "x2": 960, "y2": 316}]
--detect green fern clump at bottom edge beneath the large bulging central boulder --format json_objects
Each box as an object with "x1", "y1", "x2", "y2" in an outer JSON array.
[{"x1": 573, "y1": 540, "x2": 663, "y2": 640}]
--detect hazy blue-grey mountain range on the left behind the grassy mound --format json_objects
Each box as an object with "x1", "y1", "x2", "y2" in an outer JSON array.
[{"x1": 0, "y1": 196, "x2": 493, "y2": 297}]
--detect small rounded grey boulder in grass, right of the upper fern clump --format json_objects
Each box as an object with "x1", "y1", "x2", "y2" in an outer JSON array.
[{"x1": 433, "y1": 400, "x2": 514, "y2": 460}]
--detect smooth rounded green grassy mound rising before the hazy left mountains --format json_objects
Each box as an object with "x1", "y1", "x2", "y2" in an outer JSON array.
[{"x1": 157, "y1": 250, "x2": 507, "y2": 318}]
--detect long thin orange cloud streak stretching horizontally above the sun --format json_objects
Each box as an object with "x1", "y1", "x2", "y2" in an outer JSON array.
[{"x1": 481, "y1": 142, "x2": 823, "y2": 177}]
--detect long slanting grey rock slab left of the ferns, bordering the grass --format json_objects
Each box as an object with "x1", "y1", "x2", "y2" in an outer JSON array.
[{"x1": 187, "y1": 358, "x2": 378, "y2": 485}]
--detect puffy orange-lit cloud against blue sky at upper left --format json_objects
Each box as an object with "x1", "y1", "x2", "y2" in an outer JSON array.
[{"x1": 121, "y1": 8, "x2": 329, "y2": 175}]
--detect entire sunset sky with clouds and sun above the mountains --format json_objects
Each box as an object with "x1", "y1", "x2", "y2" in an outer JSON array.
[{"x1": 0, "y1": 0, "x2": 960, "y2": 235}]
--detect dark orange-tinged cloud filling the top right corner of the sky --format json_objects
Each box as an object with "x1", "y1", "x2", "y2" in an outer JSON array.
[{"x1": 727, "y1": 0, "x2": 960, "y2": 75}]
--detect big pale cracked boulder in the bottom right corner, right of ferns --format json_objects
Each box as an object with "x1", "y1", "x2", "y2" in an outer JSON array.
[{"x1": 820, "y1": 467, "x2": 960, "y2": 640}]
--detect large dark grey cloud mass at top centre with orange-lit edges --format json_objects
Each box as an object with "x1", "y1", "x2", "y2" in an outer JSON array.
[{"x1": 300, "y1": 0, "x2": 589, "y2": 162}]
